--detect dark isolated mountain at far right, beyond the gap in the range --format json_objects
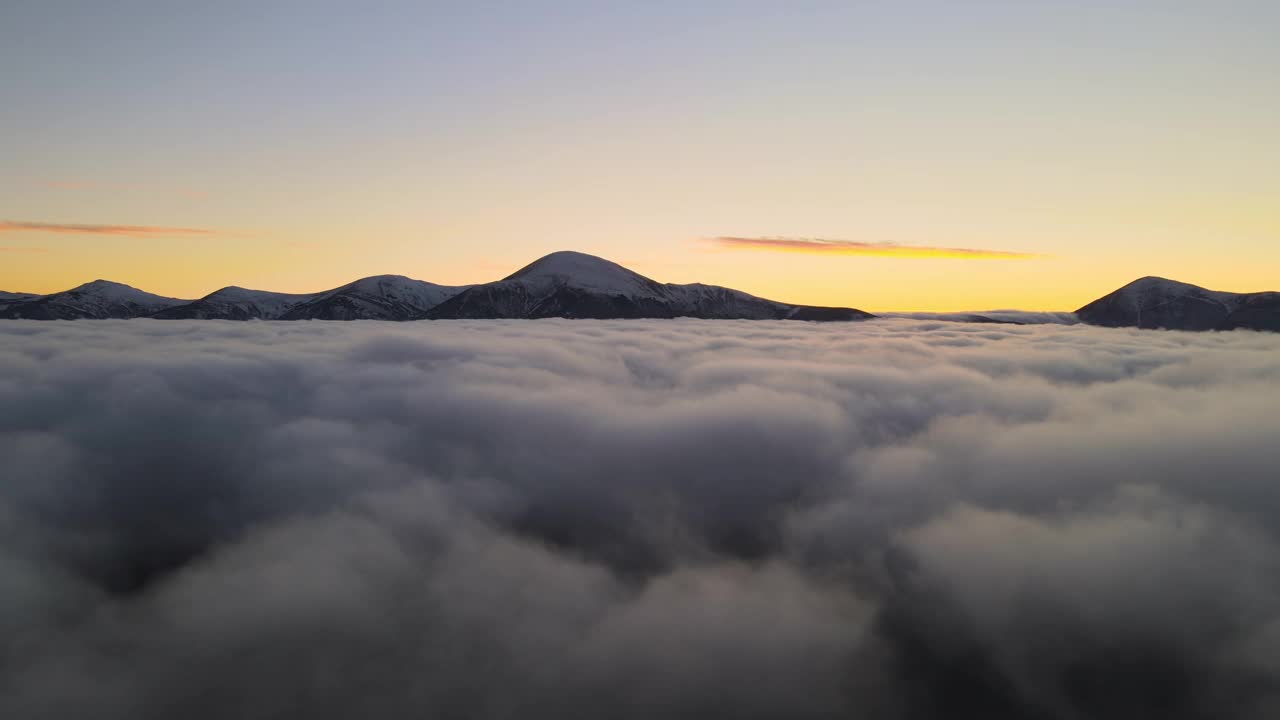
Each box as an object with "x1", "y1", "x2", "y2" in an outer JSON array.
[{"x1": 1076, "y1": 277, "x2": 1280, "y2": 331}]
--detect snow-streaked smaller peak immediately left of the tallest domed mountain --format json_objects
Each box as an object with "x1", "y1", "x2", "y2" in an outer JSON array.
[{"x1": 280, "y1": 275, "x2": 471, "y2": 320}]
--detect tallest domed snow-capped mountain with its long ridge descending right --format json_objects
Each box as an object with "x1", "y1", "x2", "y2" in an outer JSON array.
[{"x1": 426, "y1": 251, "x2": 870, "y2": 320}]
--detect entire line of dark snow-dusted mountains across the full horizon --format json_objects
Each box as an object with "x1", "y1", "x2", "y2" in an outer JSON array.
[{"x1": 0, "y1": 251, "x2": 1280, "y2": 332}]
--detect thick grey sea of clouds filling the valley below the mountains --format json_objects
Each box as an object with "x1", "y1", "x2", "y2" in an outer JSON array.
[{"x1": 0, "y1": 320, "x2": 1280, "y2": 720}]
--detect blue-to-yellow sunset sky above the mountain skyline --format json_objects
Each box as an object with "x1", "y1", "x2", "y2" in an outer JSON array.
[{"x1": 0, "y1": 0, "x2": 1280, "y2": 310}]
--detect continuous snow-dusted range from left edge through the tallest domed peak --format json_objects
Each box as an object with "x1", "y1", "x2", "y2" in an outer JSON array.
[{"x1": 0, "y1": 251, "x2": 873, "y2": 320}]
